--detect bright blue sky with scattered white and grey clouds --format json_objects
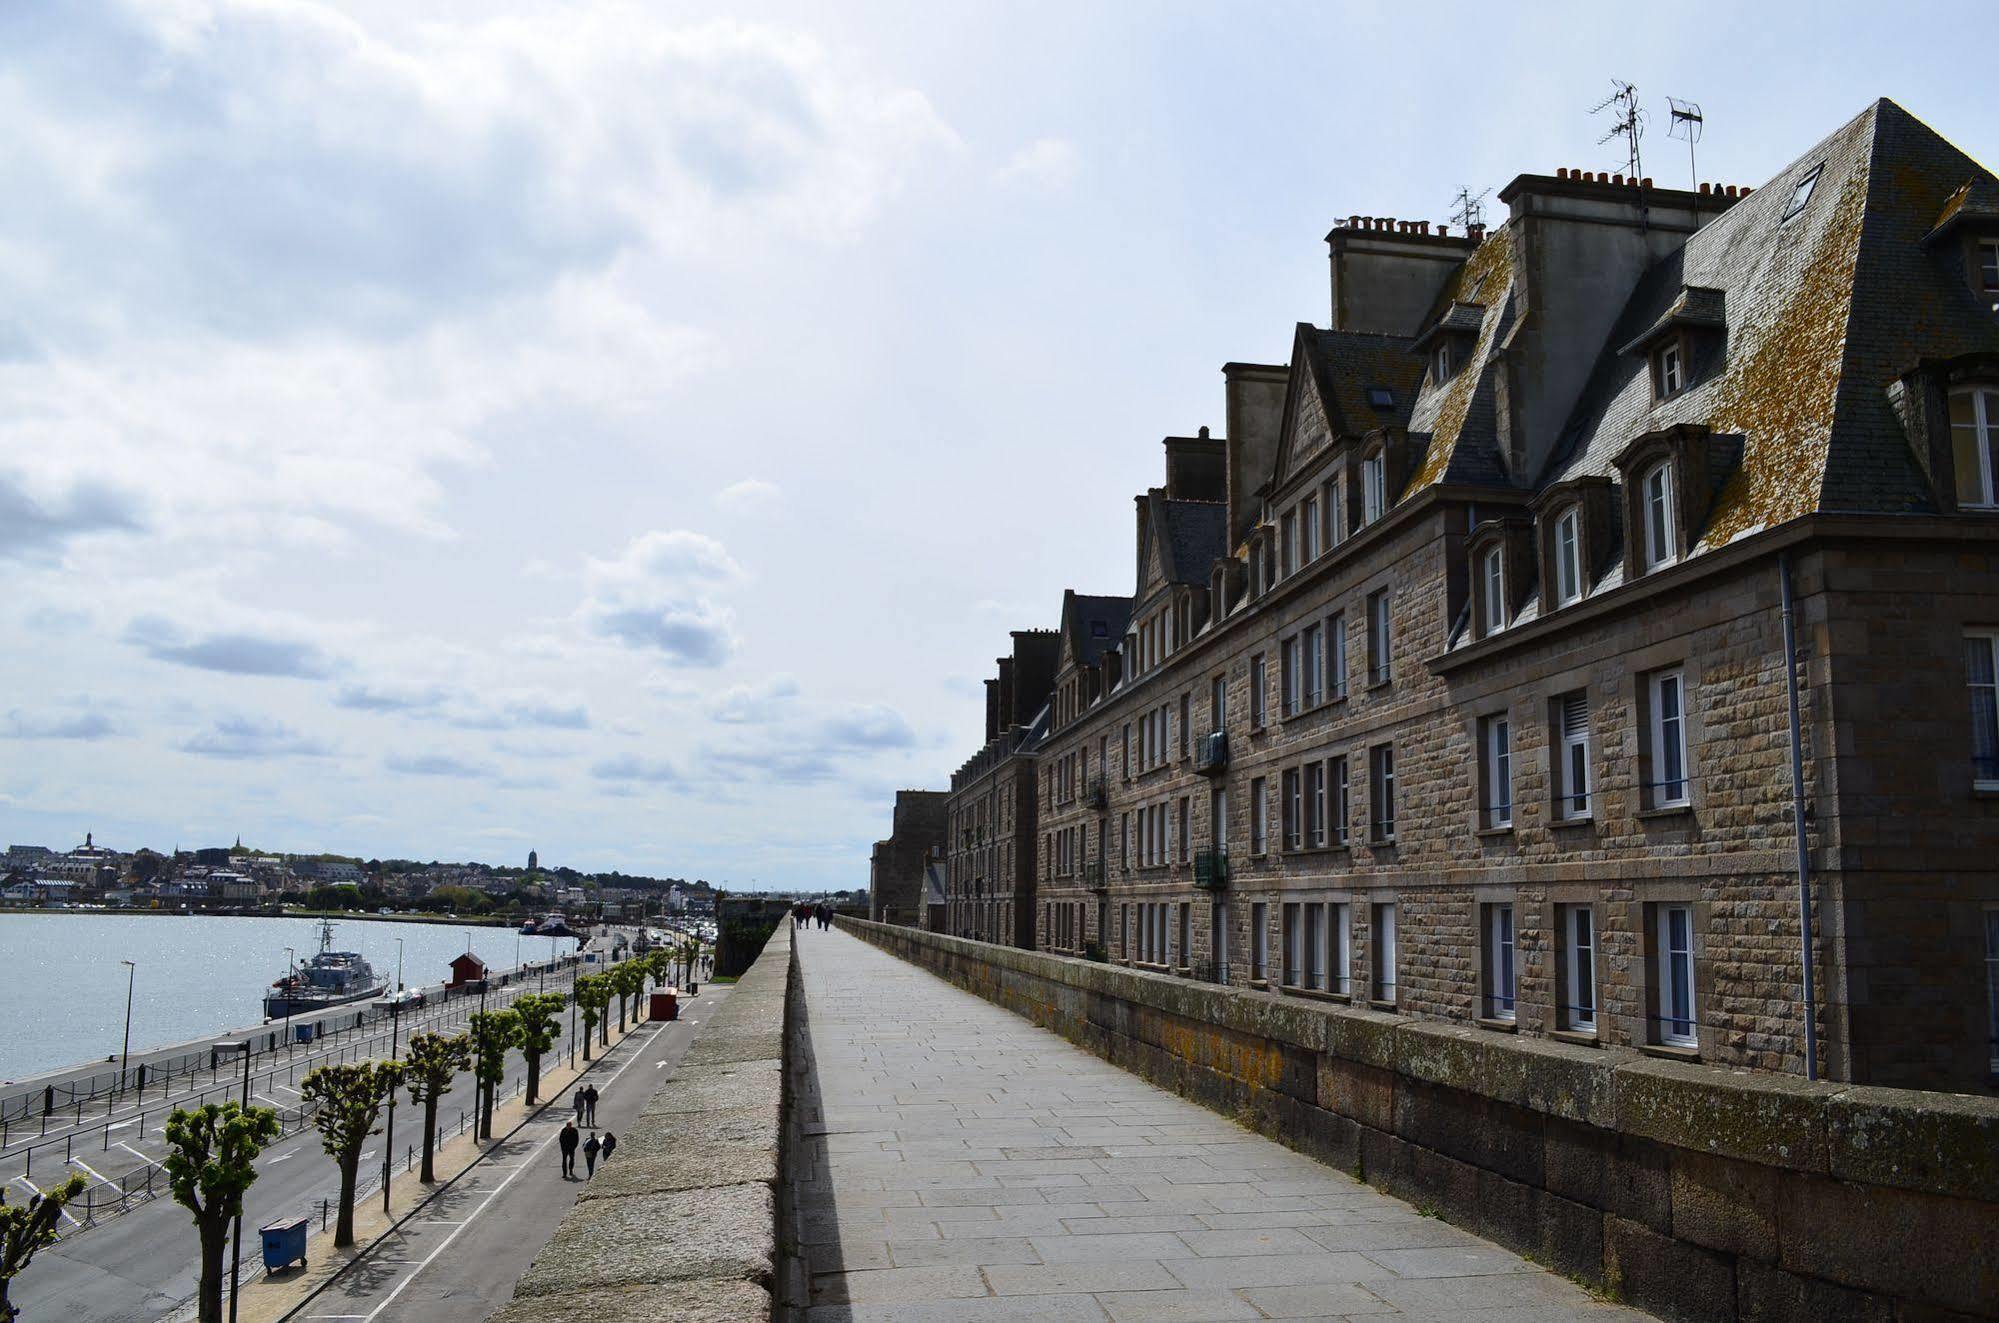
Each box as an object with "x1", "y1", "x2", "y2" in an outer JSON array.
[{"x1": 0, "y1": 0, "x2": 1999, "y2": 885}]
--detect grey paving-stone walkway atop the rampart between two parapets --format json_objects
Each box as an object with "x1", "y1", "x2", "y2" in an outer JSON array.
[{"x1": 786, "y1": 931, "x2": 1649, "y2": 1323}]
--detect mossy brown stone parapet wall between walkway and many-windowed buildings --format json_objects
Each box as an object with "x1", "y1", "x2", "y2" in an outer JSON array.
[{"x1": 842, "y1": 919, "x2": 1999, "y2": 1323}]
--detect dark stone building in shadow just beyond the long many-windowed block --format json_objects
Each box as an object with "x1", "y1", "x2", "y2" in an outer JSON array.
[{"x1": 944, "y1": 630, "x2": 1057, "y2": 949}]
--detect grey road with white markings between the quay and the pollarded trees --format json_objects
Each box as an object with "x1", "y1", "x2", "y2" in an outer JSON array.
[{"x1": 10, "y1": 931, "x2": 695, "y2": 1323}]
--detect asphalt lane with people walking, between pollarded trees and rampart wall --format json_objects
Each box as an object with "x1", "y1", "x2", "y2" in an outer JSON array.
[{"x1": 294, "y1": 985, "x2": 730, "y2": 1323}]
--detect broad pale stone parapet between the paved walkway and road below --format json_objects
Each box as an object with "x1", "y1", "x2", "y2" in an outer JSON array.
[{"x1": 494, "y1": 923, "x2": 792, "y2": 1323}]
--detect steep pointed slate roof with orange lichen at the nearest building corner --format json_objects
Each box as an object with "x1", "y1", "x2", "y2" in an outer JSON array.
[{"x1": 1543, "y1": 100, "x2": 1999, "y2": 552}]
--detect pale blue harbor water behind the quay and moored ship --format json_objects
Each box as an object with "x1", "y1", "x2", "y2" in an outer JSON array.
[{"x1": 0, "y1": 913, "x2": 576, "y2": 1081}]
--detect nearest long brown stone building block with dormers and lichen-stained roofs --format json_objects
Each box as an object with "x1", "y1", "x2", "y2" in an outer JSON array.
[{"x1": 1035, "y1": 100, "x2": 1999, "y2": 1089}]
